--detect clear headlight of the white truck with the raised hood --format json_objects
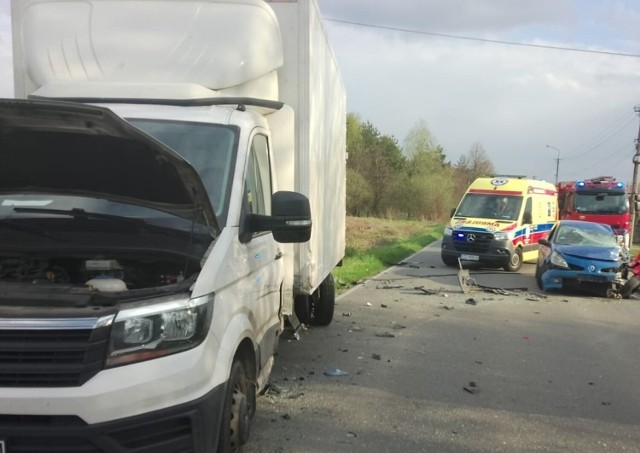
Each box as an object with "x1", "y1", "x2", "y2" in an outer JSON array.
[{"x1": 106, "y1": 295, "x2": 213, "y2": 367}]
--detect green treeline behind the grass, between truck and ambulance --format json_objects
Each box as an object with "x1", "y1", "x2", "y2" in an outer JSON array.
[{"x1": 347, "y1": 113, "x2": 494, "y2": 221}]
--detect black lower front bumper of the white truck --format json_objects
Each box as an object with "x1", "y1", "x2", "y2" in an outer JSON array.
[{"x1": 0, "y1": 384, "x2": 225, "y2": 453}]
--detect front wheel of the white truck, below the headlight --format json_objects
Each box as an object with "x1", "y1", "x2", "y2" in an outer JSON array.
[{"x1": 218, "y1": 359, "x2": 256, "y2": 453}]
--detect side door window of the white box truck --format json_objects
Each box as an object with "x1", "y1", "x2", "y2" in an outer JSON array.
[{"x1": 245, "y1": 135, "x2": 271, "y2": 215}]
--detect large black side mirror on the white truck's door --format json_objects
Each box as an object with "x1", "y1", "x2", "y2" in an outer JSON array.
[{"x1": 248, "y1": 191, "x2": 312, "y2": 243}]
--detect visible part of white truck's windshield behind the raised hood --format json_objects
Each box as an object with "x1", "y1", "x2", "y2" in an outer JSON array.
[{"x1": 127, "y1": 118, "x2": 238, "y2": 227}]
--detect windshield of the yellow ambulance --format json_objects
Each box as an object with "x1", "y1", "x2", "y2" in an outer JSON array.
[{"x1": 455, "y1": 193, "x2": 522, "y2": 220}]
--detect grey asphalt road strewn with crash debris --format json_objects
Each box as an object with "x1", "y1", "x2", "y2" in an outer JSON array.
[{"x1": 244, "y1": 243, "x2": 640, "y2": 453}]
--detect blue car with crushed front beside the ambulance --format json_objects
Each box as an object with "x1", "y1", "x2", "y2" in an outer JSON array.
[{"x1": 536, "y1": 220, "x2": 628, "y2": 297}]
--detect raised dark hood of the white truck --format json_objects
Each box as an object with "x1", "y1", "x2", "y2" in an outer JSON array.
[{"x1": 0, "y1": 99, "x2": 219, "y2": 235}]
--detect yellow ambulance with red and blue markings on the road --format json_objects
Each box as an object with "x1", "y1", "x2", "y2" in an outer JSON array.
[{"x1": 441, "y1": 176, "x2": 558, "y2": 272}]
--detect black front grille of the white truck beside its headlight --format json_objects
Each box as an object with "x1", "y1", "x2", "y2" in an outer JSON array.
[{"x1": 0, "y1": 326, "x2": 109, "y2": 387}]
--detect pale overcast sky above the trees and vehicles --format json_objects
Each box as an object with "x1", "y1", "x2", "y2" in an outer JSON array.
[{"x1": 0, "y1": 0, "x2": 640, "y2": 182}]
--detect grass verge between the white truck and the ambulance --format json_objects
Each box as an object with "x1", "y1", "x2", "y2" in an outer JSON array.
[{"x1": 333, "y1": 217, "x2": 443, "y2": 292}]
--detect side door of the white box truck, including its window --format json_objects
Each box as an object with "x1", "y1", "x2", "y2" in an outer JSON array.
[{"x1": 240, "y1": 134, "x2": 284, "y2": 365}]
